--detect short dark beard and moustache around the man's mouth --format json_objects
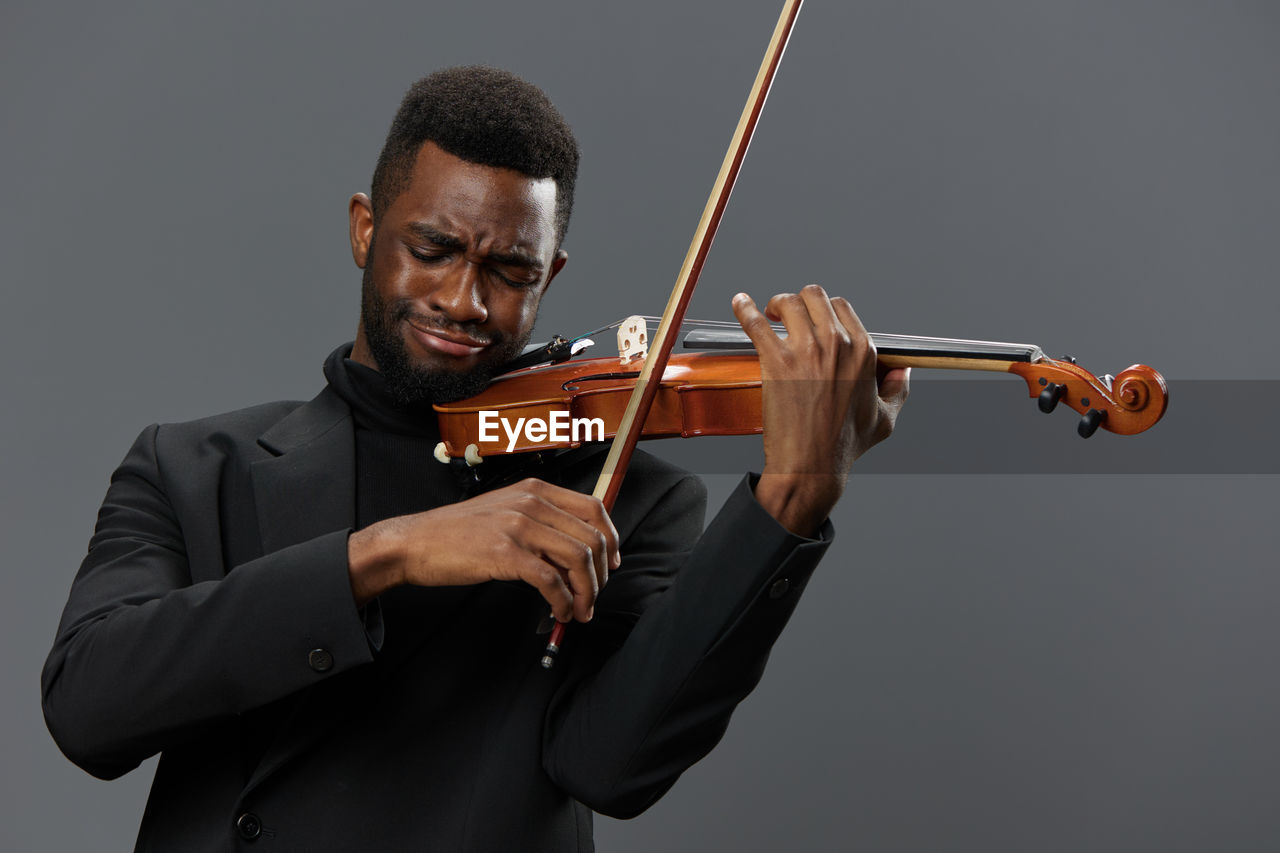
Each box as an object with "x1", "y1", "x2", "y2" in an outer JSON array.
[{"x1": 360, "y1": 261, "x2": 531, "y2": 407}]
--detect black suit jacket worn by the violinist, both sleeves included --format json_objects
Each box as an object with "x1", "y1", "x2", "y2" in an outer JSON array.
[{"x1": 42, "y1": 388, "x2": 829, "y2": 852}]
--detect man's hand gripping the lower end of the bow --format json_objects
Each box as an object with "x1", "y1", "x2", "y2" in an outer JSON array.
[{"x1": 347, "y1": 479, "x2": 622, "y2": 622}]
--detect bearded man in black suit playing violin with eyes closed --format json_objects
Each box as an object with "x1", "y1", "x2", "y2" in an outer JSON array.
[{"x1": 44, "y1": 68, "x2": 906, "y2": 850}]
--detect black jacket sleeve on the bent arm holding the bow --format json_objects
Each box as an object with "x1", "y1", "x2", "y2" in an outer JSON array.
[{"x1": 41, "y1": 427, "x2": 372, "y2": 779}]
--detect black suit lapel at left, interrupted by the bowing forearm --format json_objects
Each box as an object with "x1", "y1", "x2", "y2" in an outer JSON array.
[{"x1": 244, "y1": 387, "x2": 370, "y2": 794}]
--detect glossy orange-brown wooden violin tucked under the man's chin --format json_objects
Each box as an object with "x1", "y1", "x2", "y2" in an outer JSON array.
[{"x1": 434, "y1": 316, "x2": 1169, "y2": 466}]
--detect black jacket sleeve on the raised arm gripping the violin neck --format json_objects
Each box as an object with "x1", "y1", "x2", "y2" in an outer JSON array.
[{"x1": 543, "y1": 478, "x2": 832, "y2": 817}]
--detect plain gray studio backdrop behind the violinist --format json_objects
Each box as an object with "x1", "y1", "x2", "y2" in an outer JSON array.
[{"x1": 0, "y1": 0, "x2": 1280, "y2": 853}]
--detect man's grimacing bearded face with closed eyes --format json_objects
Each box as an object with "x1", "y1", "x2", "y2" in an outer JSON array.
[{"x1": 351, "y1": 142, "x2": 566, "y2": 403}]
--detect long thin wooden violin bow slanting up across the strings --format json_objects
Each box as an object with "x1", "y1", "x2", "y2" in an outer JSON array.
[{"x1": 543, "y1": 0, "x2": 804, "y2": 670}]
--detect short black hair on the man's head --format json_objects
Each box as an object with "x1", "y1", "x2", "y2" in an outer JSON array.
[{"x1": 372, "y1": 65, "x2": 579, "y2": 245}]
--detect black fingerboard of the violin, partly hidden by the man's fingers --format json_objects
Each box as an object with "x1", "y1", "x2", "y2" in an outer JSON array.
[{"x1": 684, "y1": 328, "x2": 1044, "y2": 371}]
